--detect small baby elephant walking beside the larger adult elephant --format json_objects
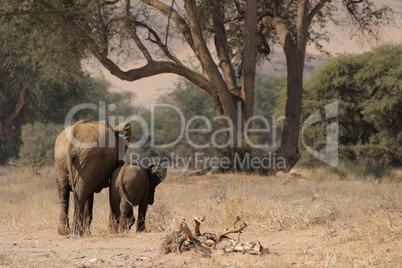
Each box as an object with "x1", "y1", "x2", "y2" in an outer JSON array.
[{"x1": 109, "y1": 163, "x2": 167, "y2": 232}]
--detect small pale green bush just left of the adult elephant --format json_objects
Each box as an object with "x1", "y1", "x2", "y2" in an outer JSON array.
[{"x1": 19, "y1": 122, "x2": 63, "y2": 165}]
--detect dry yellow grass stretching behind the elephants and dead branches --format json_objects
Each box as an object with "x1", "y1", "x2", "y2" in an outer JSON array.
[{"x1": 0, "y1": 167, "x2": 402, "y2": 266}]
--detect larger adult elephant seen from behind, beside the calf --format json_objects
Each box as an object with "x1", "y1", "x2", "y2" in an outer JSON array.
[{"x1": 55, "y1": 120, "x2": 131, "y2": 235}]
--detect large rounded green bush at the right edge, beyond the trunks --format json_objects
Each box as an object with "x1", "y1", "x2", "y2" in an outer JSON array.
[{"x1": 303, "y1": 44, "x2": 402, "y2": 165}]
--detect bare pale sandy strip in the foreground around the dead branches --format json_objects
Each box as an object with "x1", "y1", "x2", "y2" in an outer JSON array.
[{"x1": 0, "y1": 226, "x2": 344, "y2": 267}]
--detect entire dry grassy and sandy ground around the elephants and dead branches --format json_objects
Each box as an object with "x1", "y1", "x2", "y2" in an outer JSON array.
[{"x1": 0, "y1": 166, "x2": 402, "y2": 267}]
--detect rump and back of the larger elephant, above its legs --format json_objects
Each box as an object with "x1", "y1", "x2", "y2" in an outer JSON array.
[{"x1": 55, "y1": 120, "x2": 118, "y2": 196}]
